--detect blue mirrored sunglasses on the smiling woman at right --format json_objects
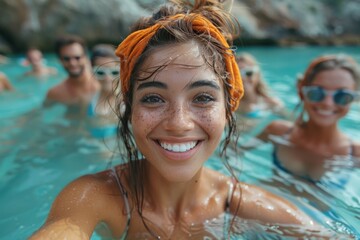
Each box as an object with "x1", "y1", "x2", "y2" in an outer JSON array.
[{"x1": 301, "y1": 86, "x2": 360, "y2": 106}]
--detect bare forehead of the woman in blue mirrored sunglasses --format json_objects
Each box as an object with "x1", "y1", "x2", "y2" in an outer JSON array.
[{"x1": 312, "y1": 68, "x2": 356, "y2": 89}]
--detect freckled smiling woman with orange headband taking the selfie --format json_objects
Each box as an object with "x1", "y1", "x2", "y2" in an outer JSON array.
[{"x1": 28, "y1": 0, "x2": 348, "y2": 239}]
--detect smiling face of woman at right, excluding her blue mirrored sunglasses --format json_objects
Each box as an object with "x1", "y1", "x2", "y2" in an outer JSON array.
[{"x1": 304, "y1": 68, "x2": 356, "y2": 126}]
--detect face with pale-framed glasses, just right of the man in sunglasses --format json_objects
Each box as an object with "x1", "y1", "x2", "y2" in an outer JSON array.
[{"x1": 93, "y1": 57, "x2": 120, "y2": 92}]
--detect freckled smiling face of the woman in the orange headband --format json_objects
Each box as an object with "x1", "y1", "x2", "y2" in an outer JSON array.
[{"x1": 131, "y1": 42, "x2": 226, "y2": 182}]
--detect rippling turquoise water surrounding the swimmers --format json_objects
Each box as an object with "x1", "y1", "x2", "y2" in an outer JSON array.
[{"x1": 0, "y1": 47, "x2": 360, "y2": 239}]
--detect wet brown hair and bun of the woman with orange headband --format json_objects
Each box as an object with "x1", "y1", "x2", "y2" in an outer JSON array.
[{"x1": 116, "y1": 0, "x2": 237, "y2": 236}]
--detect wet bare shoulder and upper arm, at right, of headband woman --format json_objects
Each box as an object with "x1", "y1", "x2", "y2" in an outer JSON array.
[{"x1": 231, "y1": 183, "x2": 315, "y2": 227}]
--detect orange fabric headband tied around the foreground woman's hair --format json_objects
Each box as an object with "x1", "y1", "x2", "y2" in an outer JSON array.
[{"x1": 115, "y1": 14, "x2": 244, "y2": 111}]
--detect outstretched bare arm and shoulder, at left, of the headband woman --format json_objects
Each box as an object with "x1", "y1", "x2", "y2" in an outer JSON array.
[{"x1": 32, "y1": 171, "x2": 123, "y2": 239}]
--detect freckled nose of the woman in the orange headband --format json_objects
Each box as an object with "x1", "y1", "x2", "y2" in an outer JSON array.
[{"x1": 164, "y1": 102, "x2": 194, "y2": 133}]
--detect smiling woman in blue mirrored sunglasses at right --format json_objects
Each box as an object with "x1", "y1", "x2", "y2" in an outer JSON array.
[{"x1": 258, "y1": 54, "x2": 360, "y2": 184}]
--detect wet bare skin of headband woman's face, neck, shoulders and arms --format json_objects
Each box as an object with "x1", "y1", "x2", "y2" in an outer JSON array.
[{"x1": 32, "y1": 42, "x2": 326, "y2": 239}]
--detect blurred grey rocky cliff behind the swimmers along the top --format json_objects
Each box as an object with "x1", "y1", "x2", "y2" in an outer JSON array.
[{"x1": 0, "y1": 0, "x2": 360, "y2": 53}]
